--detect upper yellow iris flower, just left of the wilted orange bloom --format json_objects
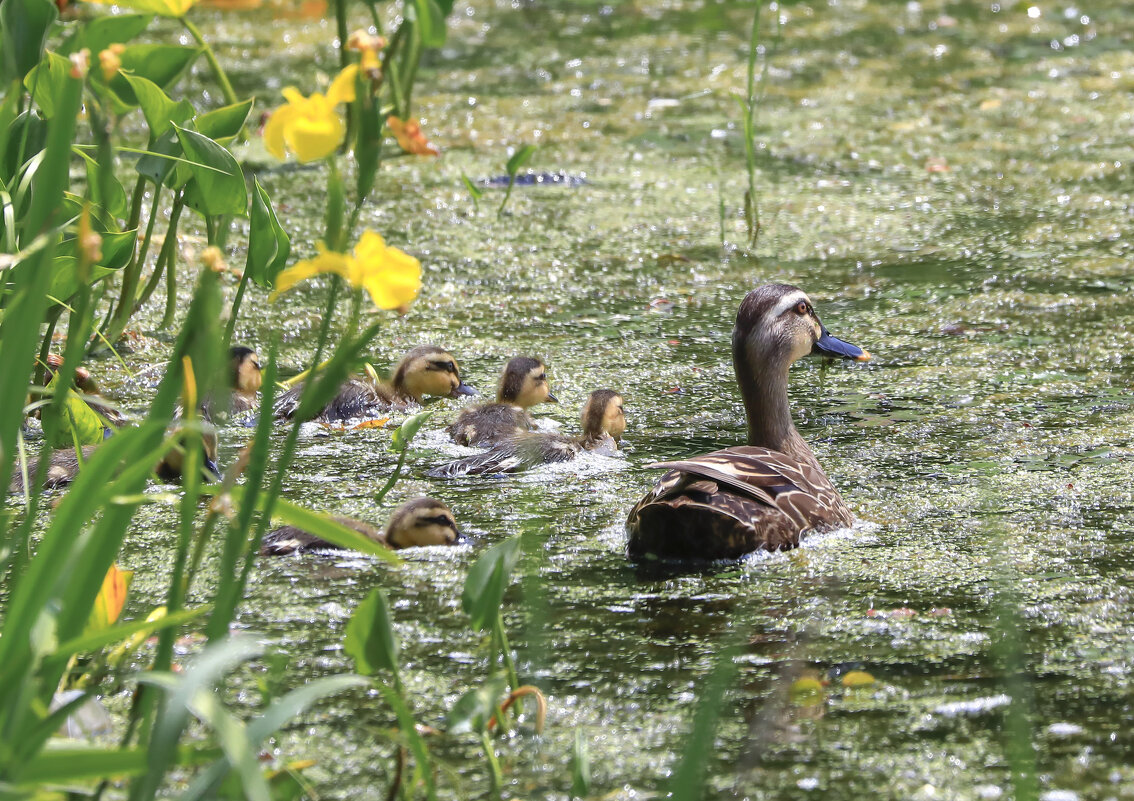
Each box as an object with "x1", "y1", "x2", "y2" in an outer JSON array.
[{"x1": 264, "y1": 65, "x2": 358, "y2": 163}]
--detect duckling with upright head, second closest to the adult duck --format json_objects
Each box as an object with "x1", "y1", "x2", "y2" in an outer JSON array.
[{"x1": 449, "y1": 356, "x2": 559, "y2": 448}]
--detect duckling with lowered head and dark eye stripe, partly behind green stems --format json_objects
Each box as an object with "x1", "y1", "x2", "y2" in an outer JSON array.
[{"x1": 274, "y1": 345, "x2": 476, "y2": 422}]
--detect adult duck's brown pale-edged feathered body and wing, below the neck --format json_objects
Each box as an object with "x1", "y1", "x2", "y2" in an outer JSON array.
[{"x1": 626, "y1": 447, "x2": 851, "y2": 559}]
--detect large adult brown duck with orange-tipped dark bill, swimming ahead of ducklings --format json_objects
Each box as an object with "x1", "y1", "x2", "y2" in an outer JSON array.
[{"x1": 626, "y1": 284, "x2": 871, "y2": 559}]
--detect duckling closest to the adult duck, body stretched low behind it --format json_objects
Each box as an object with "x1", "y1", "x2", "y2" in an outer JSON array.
[{"x1": 426, "y1": 389, "x2": 626, "y2": 479}]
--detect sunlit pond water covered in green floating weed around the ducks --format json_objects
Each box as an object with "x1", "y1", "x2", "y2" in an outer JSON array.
[{"x1": 26, "y1": 0, "x2": 1134, "y2": 801}]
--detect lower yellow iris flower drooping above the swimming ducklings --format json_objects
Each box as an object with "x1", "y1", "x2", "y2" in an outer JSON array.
[{"x1": 271, "y1": 231, "x2": 422, "y2": 309}]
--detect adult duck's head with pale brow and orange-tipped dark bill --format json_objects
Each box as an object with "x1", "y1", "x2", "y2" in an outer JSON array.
[{"x1": 733, "y1": 284, "x2": 871, "y2": 374}]
